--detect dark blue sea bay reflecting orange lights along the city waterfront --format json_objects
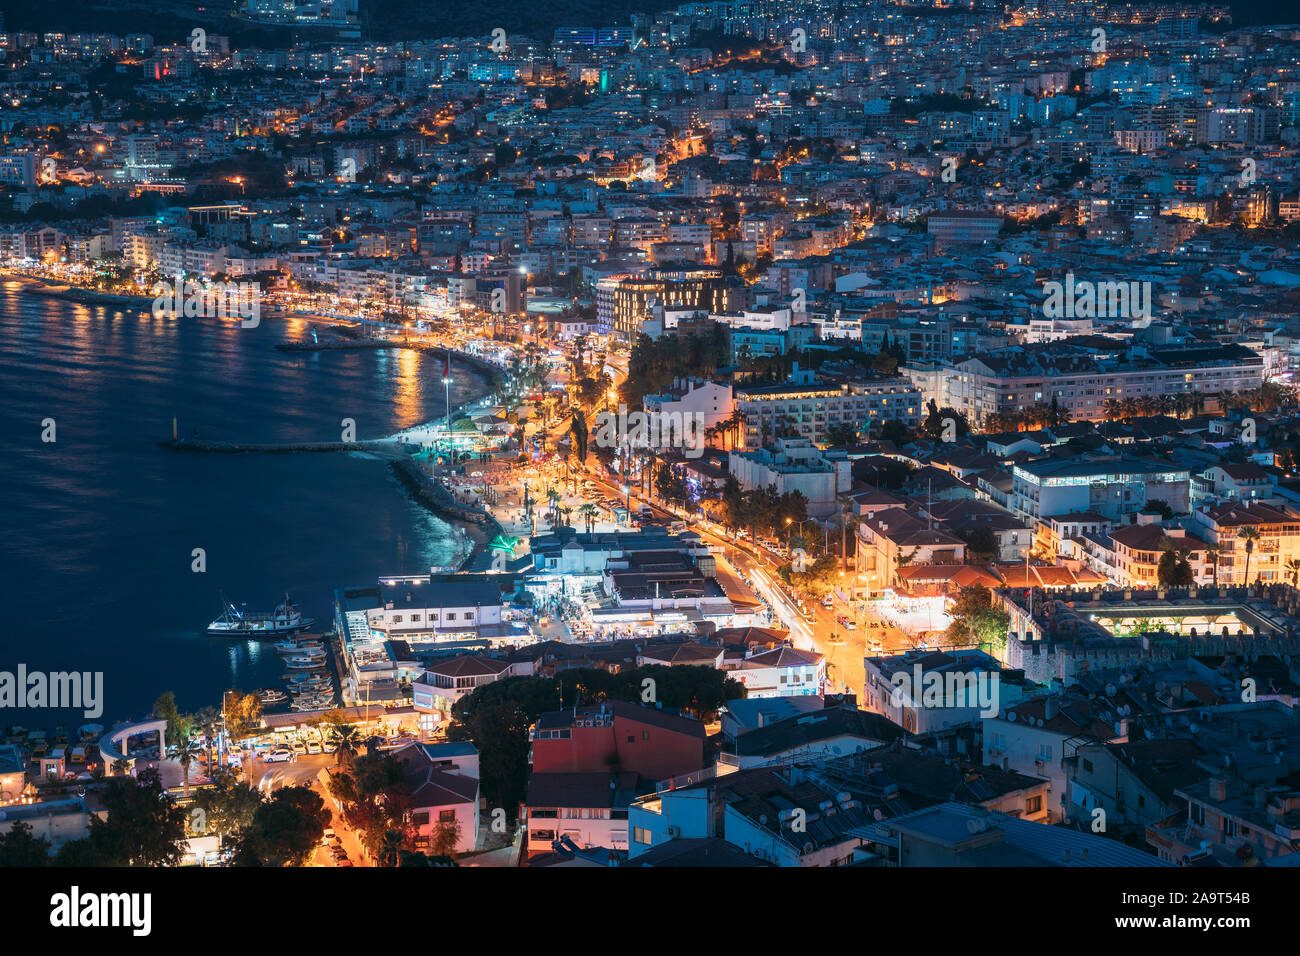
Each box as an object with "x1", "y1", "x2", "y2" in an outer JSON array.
[{"x1": 0, "y1": 281, "x2": 485, "y2": 728}]
